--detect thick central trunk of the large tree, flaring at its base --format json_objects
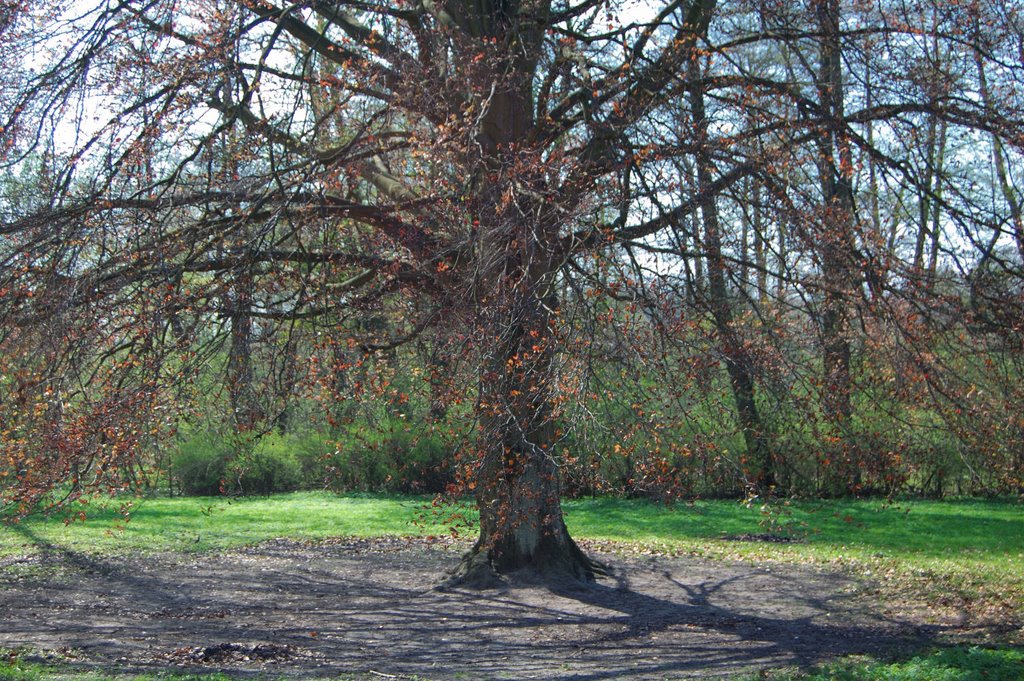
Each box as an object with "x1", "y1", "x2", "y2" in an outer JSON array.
[{"x1": 450, "y1": 50, "x2": 605, "y2": 587}]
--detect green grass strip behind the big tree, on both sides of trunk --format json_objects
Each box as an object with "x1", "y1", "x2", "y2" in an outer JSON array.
[{"x1": 0, "y1": 493, "x2": 1024, "y2": 573}]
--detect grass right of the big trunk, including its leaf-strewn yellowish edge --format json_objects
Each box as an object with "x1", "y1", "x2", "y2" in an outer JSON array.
[{"x1": 566, "y1": 491, "x2": 1024, "y2": 634}]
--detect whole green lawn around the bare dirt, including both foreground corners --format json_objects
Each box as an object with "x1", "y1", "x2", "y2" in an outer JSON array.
[{"x1": 0, "y1": 493, "x2": 1024, "y2": 681}]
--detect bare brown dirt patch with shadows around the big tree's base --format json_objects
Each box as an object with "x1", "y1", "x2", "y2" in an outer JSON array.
[{"x1": 0, "y1": 540, "x2": 950, "y2": 679}]
